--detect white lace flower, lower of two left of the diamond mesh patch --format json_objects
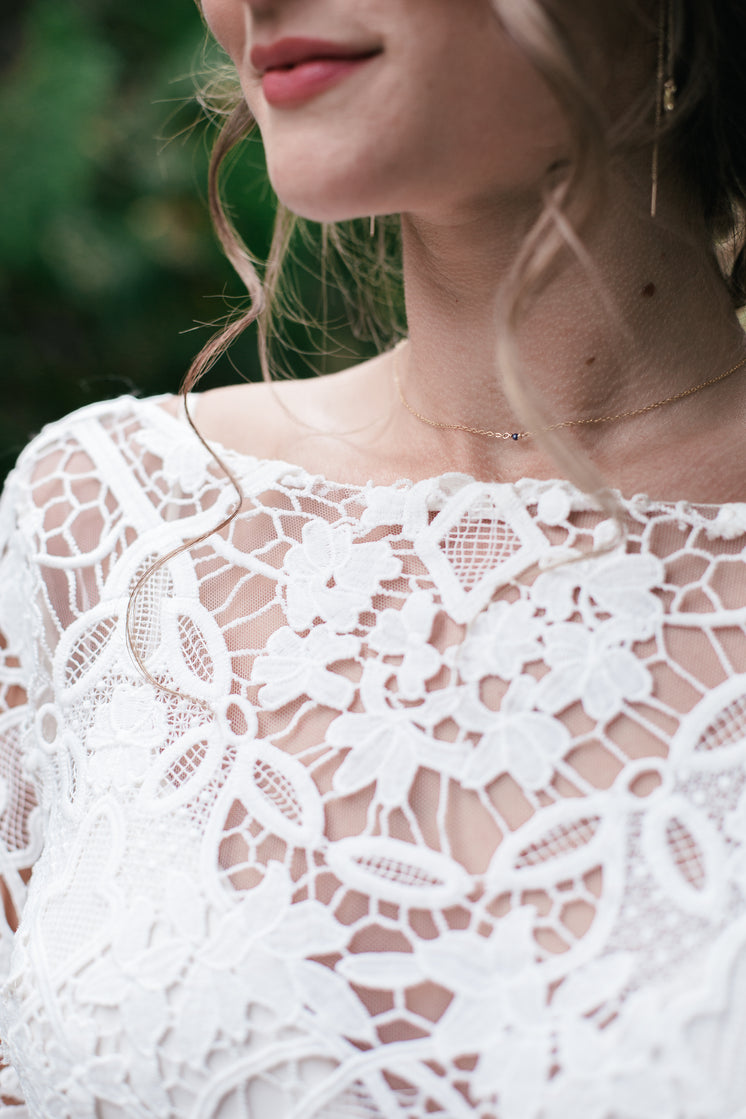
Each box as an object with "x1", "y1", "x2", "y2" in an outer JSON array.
[{"x1": 252, "y1": 626, "x2": 360, "y2": 711}]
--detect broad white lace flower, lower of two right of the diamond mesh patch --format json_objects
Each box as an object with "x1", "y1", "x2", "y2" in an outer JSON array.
[{"x1": 537, "y1": 621, "x2": 653, "y2": 722}]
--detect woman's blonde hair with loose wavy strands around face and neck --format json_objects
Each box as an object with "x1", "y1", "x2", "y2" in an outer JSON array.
[{"x1": 128, "y1": 0, "x2": 746, "y2": 690}]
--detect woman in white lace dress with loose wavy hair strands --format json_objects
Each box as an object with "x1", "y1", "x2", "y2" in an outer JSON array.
[{"x1": 0, "y1": 0, "x2": 746, "y2": 1119}]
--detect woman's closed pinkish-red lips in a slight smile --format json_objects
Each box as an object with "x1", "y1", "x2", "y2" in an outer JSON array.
[{"x1": 251, "y1": 38, "x2": 380, "y2": 107}]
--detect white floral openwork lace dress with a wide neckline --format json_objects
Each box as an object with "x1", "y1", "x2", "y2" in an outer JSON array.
[{"x1": 0, "y1": 398, "x2": 746, "y2": 1119}]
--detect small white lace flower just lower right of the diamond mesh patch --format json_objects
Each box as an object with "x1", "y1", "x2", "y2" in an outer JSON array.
[{"x1": 459, "y1": 602, "x2": 545, "y2": 684}]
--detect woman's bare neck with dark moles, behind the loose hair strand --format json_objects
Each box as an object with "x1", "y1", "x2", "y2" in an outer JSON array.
[{"x1": 400, "y1": 173, "x2": 745, "y2": 477}]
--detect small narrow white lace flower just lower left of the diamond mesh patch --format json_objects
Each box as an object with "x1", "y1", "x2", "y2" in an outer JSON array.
[{"x1": 368, "y1": 591, "x2": 441, "y2": 699}]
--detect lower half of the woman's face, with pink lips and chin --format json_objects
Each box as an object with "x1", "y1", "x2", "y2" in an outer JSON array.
[{"x1": 202, "y1": 0, "x2": 567, "y2": 220}]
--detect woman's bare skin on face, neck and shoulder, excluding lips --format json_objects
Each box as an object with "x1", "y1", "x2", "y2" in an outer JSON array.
[{"x1": 194, "y1": 0, "x2": 746, "y2": 502}]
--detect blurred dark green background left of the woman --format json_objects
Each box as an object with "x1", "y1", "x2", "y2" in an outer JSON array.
[{"x1": 0, "y1": 0, "x2": 395, "y2": 476}]
